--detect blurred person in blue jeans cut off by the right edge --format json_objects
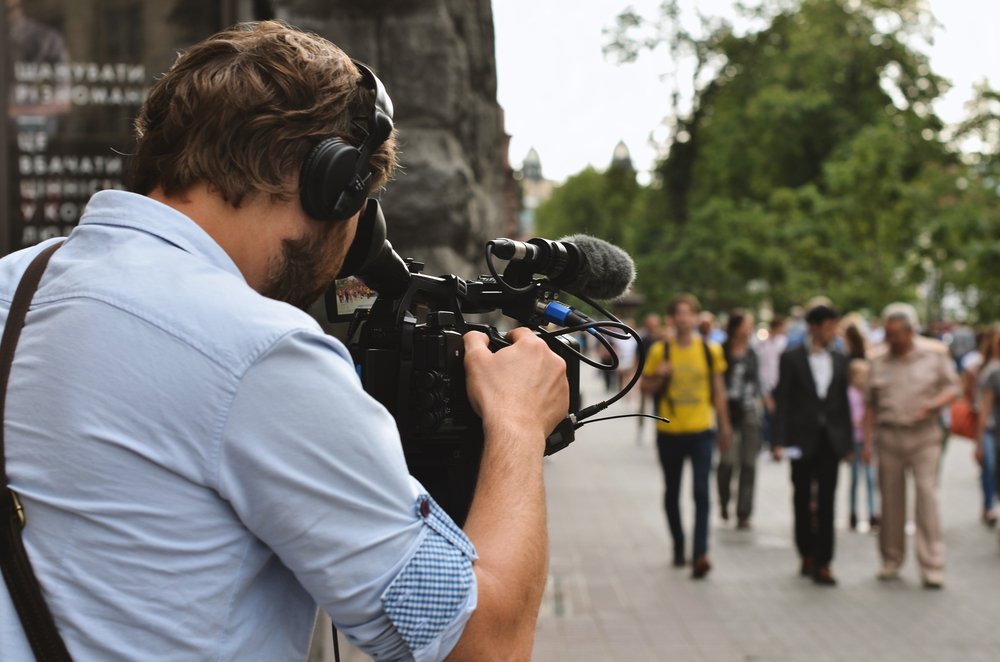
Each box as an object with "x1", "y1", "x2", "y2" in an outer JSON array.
[{"x1": 974, "y1": 330, "x2": 1000, "y2": 526}]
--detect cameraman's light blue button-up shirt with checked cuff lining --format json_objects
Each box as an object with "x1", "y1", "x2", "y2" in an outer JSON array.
[{"x1": 0, "y1": 191, "x2": 476, "y2": 662}]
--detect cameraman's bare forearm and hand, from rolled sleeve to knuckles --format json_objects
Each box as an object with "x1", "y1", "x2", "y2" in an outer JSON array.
[{"x1": 447, "y1": 328, "x2": 569, "y2": 662}]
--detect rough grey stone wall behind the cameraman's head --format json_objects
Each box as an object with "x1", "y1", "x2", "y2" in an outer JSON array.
[{"x1": 275, "y1": 0, "x2": 506, "y2": 278}]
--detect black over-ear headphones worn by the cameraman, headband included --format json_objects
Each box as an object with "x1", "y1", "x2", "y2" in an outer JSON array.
[{"x1": 299, "y1": 60, "x2": 392, "y2": 221}]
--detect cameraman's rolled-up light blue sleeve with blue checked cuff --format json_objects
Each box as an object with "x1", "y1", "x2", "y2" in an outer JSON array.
[{"x1": 218, "y1": 332, "x2": 477, "y2": 662}]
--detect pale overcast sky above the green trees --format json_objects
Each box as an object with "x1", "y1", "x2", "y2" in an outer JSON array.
[{"x1": 493, "y1": 0, "x2": 1000, "y2": 181}]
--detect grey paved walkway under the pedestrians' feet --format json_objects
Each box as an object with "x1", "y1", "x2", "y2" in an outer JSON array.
[{"x1": 317, "y1": 370, "x2": 1000, "y2": 662}]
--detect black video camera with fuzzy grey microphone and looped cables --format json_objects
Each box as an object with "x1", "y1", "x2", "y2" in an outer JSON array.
[{"x1": 326, "y1": 200, "x2": 644, "y2": 526}]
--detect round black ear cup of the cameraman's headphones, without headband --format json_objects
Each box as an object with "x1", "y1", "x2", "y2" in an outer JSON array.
[{"x1": 299, "y1": 138, "x2": 367, "y2": 221}]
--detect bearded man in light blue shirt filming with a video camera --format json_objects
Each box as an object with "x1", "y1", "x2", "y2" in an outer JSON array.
[{"x1": 0, "y1": 22, "x2": 568, "y2": 661}]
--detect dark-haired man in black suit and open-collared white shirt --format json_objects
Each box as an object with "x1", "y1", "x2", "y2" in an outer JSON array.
[{"x1": 774, "y1": 305, "x2": 852, "y2": 586}]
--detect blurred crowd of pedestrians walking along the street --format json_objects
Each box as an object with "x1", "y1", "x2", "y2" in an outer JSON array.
[{"x1": 619, "y1": 294, "x2": 1000, "y2": 589}]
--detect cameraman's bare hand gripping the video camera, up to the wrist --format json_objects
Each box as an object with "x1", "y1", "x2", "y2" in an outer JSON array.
[{"x1": 465, "y1": 327, "x2": 569, "y2": 448}]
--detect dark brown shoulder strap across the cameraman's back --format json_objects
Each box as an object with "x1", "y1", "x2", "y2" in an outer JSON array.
[{"x1": 0, "y1": 242, "x2": 72, "y2": 662}]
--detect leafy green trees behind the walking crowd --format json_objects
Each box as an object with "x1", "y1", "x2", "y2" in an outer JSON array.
[{"x1": 538, "y1": 0, "x2": 1000, "y2": 319}]
